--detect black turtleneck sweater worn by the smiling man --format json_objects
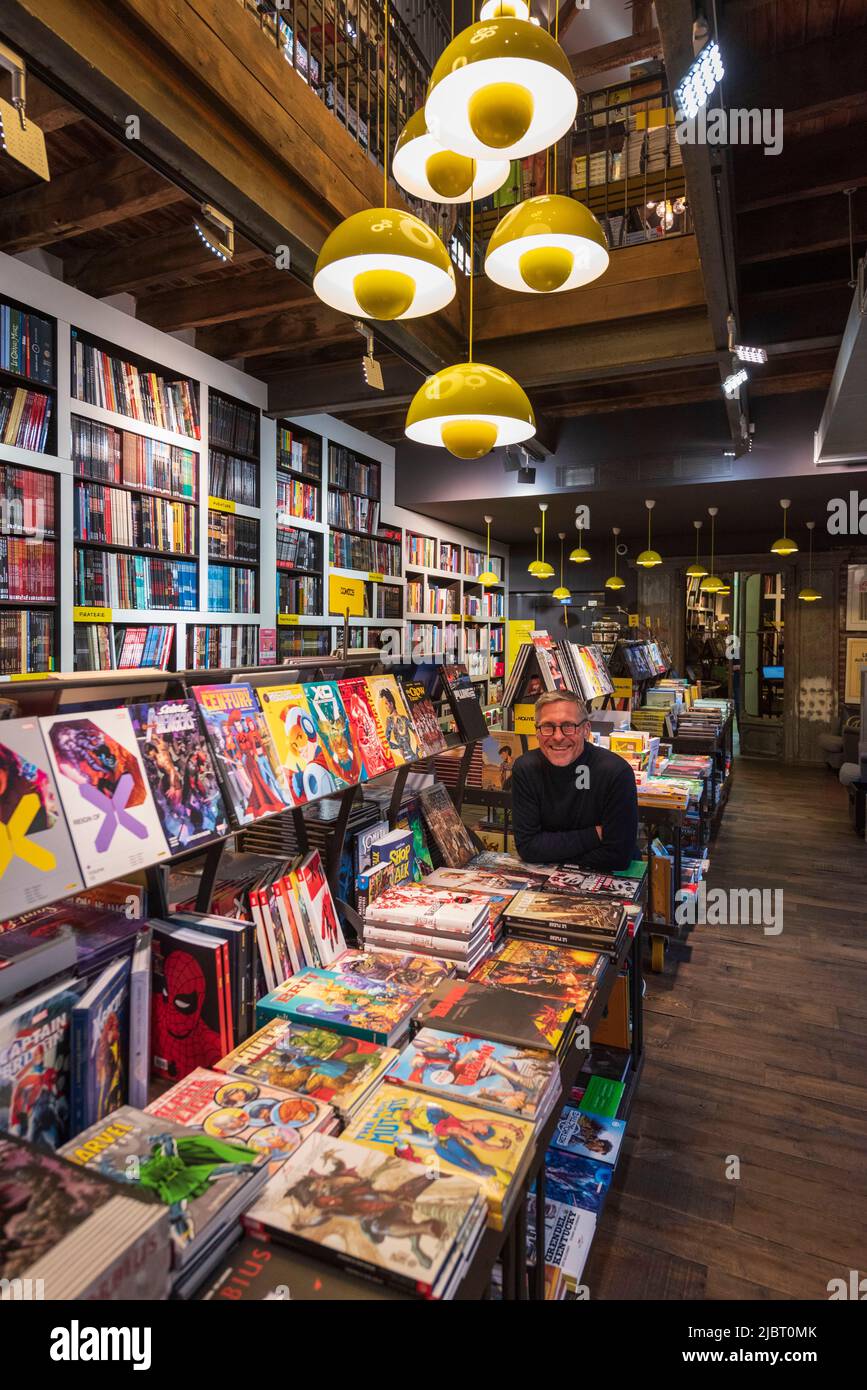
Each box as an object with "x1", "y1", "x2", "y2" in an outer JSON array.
[{"x1": 511, "y1": 744, "x2": 638, "y2": 872}]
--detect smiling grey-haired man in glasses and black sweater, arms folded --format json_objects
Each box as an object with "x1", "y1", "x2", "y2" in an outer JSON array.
[{"x1": 511, "y1": 691, "x2": 638, "y2": 873}]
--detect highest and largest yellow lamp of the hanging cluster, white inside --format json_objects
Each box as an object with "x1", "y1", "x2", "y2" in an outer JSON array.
[{"x1": 425, "y1": 18, "x2": 578, "y2": 160}]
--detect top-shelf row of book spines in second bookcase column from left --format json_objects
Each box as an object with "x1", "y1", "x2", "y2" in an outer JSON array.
[{"x1": 72, "y1": 335, "x2": 200, "y2": 439}]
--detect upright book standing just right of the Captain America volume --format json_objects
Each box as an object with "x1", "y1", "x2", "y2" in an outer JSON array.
[{"x1": 71, "y1": 959, "x2": 132, "y2": 1134}]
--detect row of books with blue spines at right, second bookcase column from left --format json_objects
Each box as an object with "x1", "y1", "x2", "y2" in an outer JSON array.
[{"x1": 75, "y1": 549, "x2": 199, "y2": 610}]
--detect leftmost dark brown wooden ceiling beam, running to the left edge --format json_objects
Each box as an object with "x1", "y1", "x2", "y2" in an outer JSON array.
[{"x1": 0, "y1": 150, "x2": 186, "y2": 256}]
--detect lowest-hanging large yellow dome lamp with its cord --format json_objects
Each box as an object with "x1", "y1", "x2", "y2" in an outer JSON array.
[{"x1": 404, "y1": 194, "x2": 536, "y2": 455}]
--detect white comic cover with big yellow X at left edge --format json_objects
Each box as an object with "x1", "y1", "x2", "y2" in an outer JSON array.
[{"x1": 0, "y1": 719, "x2": 83, "y2": 916}]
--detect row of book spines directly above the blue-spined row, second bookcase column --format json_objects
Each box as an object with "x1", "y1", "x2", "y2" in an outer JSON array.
[{"x1": 75, "y1": 482, "x2": 199, "y2": 555}]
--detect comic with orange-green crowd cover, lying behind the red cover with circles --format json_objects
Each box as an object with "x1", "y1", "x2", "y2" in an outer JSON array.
[{"x1": 215, "y1": 1019, "x2": 397, "y2": 1115}]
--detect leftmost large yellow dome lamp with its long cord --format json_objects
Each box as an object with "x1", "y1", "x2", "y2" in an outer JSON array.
[{"x1": 313, "y1": 0, "x2": 456, "y2": 321}]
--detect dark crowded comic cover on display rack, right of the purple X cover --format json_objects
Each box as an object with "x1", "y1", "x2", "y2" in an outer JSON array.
[{"x1": 129, "y1": 699, "x2": 229, "y2": 855}]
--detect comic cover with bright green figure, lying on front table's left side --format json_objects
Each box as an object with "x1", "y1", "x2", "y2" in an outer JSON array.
[{"x1": 61, "y1": 1105, "x2": 268, "y2": 1265}]
